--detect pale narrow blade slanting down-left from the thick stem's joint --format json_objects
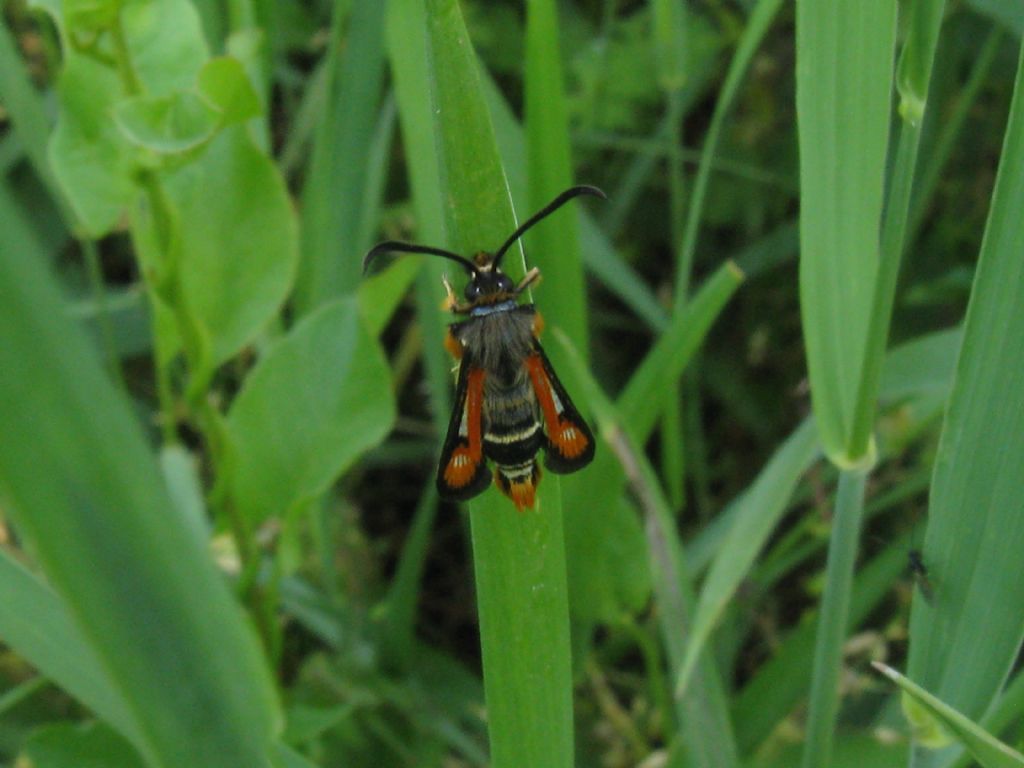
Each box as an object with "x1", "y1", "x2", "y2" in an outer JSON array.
[{"x1": 676, "y1": 420, "x2": 819, "y2": 689}]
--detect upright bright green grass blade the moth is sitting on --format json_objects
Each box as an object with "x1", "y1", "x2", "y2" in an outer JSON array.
[{"x1": 426, "y1": 0, "x2": 573, "y2": 768}]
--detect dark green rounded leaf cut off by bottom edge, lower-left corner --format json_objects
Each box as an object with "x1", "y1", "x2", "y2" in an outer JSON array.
[{"x1": 18, "y1": 723, "x2": 144, "y2": 768}]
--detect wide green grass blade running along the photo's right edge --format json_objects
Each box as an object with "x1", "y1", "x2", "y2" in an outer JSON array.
[{"x1": 908, "y1": 36, "x2": 1024, "y2": 765}]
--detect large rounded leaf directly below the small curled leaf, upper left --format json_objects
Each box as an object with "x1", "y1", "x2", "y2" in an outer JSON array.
[{"x1": 166, "y1": 126, "x2": 298, "y2": 367}]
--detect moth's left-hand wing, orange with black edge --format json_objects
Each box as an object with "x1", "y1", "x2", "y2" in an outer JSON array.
[{"x1": 437, "y1": 354, "x2": 490, "y2": 502}]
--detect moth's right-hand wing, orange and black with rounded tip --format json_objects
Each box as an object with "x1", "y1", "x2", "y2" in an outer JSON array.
[{"x1": 527, "y1": 340, "x2": 594, "y2": 474}]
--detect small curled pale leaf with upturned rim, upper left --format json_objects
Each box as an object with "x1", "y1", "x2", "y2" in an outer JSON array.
[{"x1": 114, "y1": 91, "x2": 220, "y2": 155}]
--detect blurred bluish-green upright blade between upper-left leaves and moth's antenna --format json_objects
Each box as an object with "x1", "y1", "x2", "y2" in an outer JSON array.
[{"x1": 296, "y1": 3, "x2": 387, "y2": 311}]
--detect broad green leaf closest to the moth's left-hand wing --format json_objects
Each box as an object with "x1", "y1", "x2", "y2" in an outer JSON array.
[{"x1": 227, "y1": 299, "x2": 394, "y2": 520}]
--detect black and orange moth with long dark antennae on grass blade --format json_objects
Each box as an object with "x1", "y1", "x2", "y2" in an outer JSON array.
[{"x1": 362, "y1": 185, "x2": 605, "y2": 511}]
